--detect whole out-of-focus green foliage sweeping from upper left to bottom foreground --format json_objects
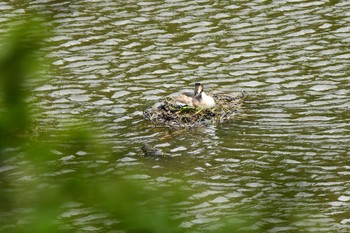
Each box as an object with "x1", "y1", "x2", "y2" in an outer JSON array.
[{"x1": 0, "y1": 14, "x2": 185, "y2": 233}]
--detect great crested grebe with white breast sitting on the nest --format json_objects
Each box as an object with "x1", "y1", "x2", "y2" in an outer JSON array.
[{"x1": 176, "y1": 83, "x2": 215, "y2": 108}]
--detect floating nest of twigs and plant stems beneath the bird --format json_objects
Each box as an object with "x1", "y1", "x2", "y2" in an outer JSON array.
[{"x1": 143, "y1": 92, "x2": 247, "y2": 127}]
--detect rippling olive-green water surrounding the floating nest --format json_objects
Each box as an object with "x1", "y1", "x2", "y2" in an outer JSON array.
[{"x1": 0, "y1": 0, "x2": 350, "y2": 232}]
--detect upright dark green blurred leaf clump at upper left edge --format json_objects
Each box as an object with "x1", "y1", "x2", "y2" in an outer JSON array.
[{"x1": 0, "y1": 16, "x2": 46, "y2": 148}]
